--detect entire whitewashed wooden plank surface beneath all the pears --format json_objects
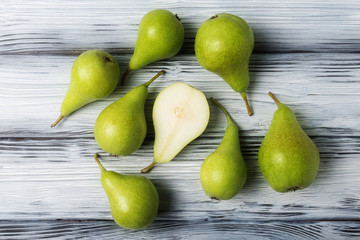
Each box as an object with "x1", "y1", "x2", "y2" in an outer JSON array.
[{"x1": 0, "y1": 0, "x2": 360, "y2": 239}]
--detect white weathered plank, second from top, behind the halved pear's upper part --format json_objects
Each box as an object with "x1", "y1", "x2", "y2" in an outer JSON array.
[{"x1": 0, "y1": 54, "x2": 360, "y2": 137}]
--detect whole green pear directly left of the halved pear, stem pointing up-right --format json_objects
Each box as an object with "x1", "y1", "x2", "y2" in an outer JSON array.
[{"x1": 94, "y1": 71, "x2": 164, "y2": 156}]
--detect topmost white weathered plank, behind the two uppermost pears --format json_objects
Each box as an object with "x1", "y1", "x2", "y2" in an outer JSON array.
[{"x1": 0, "y1": 0, "x2": 360, "y2": 54}]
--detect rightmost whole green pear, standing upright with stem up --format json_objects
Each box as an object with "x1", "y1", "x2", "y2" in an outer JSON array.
[{"x1": 259, "y1": 92, "x2": 320, "y2": 192}]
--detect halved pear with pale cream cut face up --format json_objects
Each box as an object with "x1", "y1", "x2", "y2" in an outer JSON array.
[{"x1": 141, "y1": 82, "x2": 210, "y2": 173}]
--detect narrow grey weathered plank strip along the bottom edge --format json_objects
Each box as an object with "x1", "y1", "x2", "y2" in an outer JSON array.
[{"x1": 0, "y1": 218, "x2": 360, "y2": 240}]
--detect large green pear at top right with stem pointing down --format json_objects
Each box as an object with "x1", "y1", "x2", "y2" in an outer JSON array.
[{"x1": 195, "y1": 13, "x2": 254, "y2": 116}]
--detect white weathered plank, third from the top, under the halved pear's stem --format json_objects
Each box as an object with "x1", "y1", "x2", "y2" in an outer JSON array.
[{"x1": 0, "y1": 133, "x2": 360, "y2": 221}]
